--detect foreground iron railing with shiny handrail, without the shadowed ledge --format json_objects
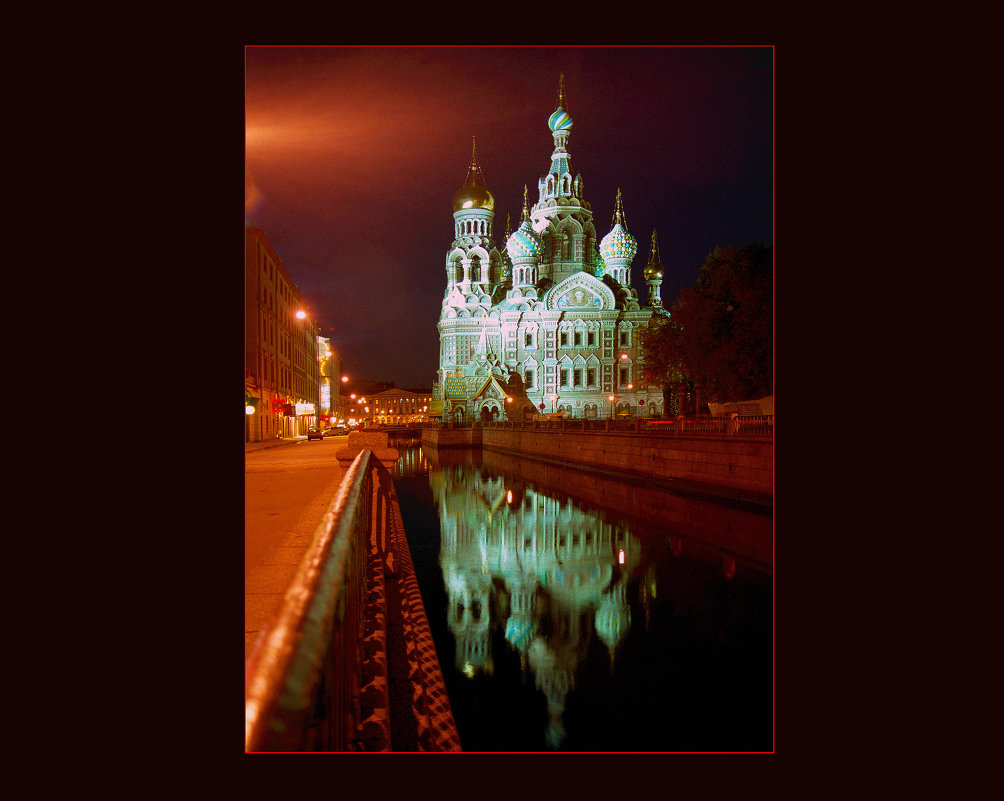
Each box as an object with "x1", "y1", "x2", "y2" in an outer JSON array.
[{"x1": 245, "y1": 451, "x2": 400, "y2": 752}]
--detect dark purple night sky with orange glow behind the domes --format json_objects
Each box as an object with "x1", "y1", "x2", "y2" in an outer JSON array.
[{"x1": 245, "y1": 46, "x2": 773, "y2": 386}]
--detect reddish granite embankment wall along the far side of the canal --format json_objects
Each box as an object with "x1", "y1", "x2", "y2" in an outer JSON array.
[{"x1": 422, "y1": 428, "x2": 774, "y2": 502}]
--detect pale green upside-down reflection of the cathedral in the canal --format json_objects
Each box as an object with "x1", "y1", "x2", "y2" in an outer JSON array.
[{"x1": 432, "y1": 464, "x2": 641, "y2": 746}]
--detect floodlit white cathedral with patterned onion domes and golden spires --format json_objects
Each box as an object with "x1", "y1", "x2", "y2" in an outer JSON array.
[{"x1": 434, "y1": 77, "x2": 665, "y2": 424}]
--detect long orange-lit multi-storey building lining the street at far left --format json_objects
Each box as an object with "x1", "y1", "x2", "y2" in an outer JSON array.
[{"x1": 244, "y1": 226, "x2": 320, "y2": 442}]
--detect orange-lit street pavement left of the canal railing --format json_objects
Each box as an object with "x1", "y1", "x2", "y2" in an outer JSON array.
[{"x1": 244, "y1": 437, "x2": 348, "y2": 659}]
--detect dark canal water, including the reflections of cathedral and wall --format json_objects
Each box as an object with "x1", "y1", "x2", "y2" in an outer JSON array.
[{"x1": 394, "y1": 443, "x2": 773, "y2": 752}]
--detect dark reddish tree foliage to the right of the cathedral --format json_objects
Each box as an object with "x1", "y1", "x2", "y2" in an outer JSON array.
[{"x1": 642, "y1": 245, "x2": 774, "y2": 403}]
